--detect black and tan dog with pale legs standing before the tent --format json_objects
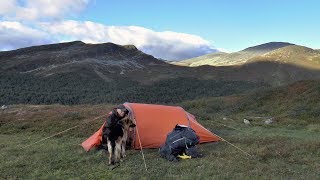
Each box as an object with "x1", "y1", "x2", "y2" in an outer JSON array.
[{"x1": 107, "y1": 116, "x2": 136, "y2": 165}]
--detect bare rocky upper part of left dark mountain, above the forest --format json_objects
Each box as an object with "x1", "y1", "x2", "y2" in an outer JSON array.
[{"x1": 0, "y1": 41, "x2": 165, "y2": 76}]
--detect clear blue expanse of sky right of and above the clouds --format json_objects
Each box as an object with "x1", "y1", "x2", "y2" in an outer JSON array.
[{"x1": 81, "y1": 0, "x2": 320, "y2": 51}]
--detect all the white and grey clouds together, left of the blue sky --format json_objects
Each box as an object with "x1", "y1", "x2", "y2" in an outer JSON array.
[{"x1": 0, "y1": 0, "x2": 218, "y2": 60}]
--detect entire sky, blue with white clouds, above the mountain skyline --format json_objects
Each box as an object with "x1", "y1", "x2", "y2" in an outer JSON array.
[{"x1": 0, "y1": 0, "x2": 320, "y2": 60}]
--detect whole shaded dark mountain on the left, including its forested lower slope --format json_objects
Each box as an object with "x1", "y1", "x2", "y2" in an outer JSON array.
[{"x1": 0, "y1": 41, "x2": 262, "y2": 104}]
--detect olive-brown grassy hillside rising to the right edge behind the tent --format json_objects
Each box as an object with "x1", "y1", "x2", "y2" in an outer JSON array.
[{"x1": 183, "y1": 80, "x2": 320, "y2": 121}]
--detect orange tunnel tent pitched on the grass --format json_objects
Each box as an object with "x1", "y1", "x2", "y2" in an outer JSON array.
[{"x1": 81, "y1": 103, "x2": 220, "y2": 151}]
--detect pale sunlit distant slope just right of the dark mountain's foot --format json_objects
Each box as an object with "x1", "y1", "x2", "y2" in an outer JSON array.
[{"x1": 173, "y1": 42, "x2": 293, "y2": 67}]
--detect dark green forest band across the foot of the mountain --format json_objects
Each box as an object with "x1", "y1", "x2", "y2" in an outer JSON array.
[{"x1": 0, "y1": 73, "x2": 264, "y2": 105}]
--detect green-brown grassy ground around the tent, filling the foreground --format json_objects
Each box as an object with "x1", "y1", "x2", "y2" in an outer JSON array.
[{"x1": 0, "y1": 103, "x2": 320, "y2": 179}]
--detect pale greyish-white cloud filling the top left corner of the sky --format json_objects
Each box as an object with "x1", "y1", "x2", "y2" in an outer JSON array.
[{"x1": 0, "y1": 0, "x2": 90, "y2": 21}]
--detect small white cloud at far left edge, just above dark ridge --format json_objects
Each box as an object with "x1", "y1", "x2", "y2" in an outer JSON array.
[{"x1": 0, "y1": 21, "x2": 53, "y2": 51}]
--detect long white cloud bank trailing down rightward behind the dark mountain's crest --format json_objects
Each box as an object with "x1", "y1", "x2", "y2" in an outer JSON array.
[{"x1": 39, "y1": 20, "x2": 218, "y2": 60}]
